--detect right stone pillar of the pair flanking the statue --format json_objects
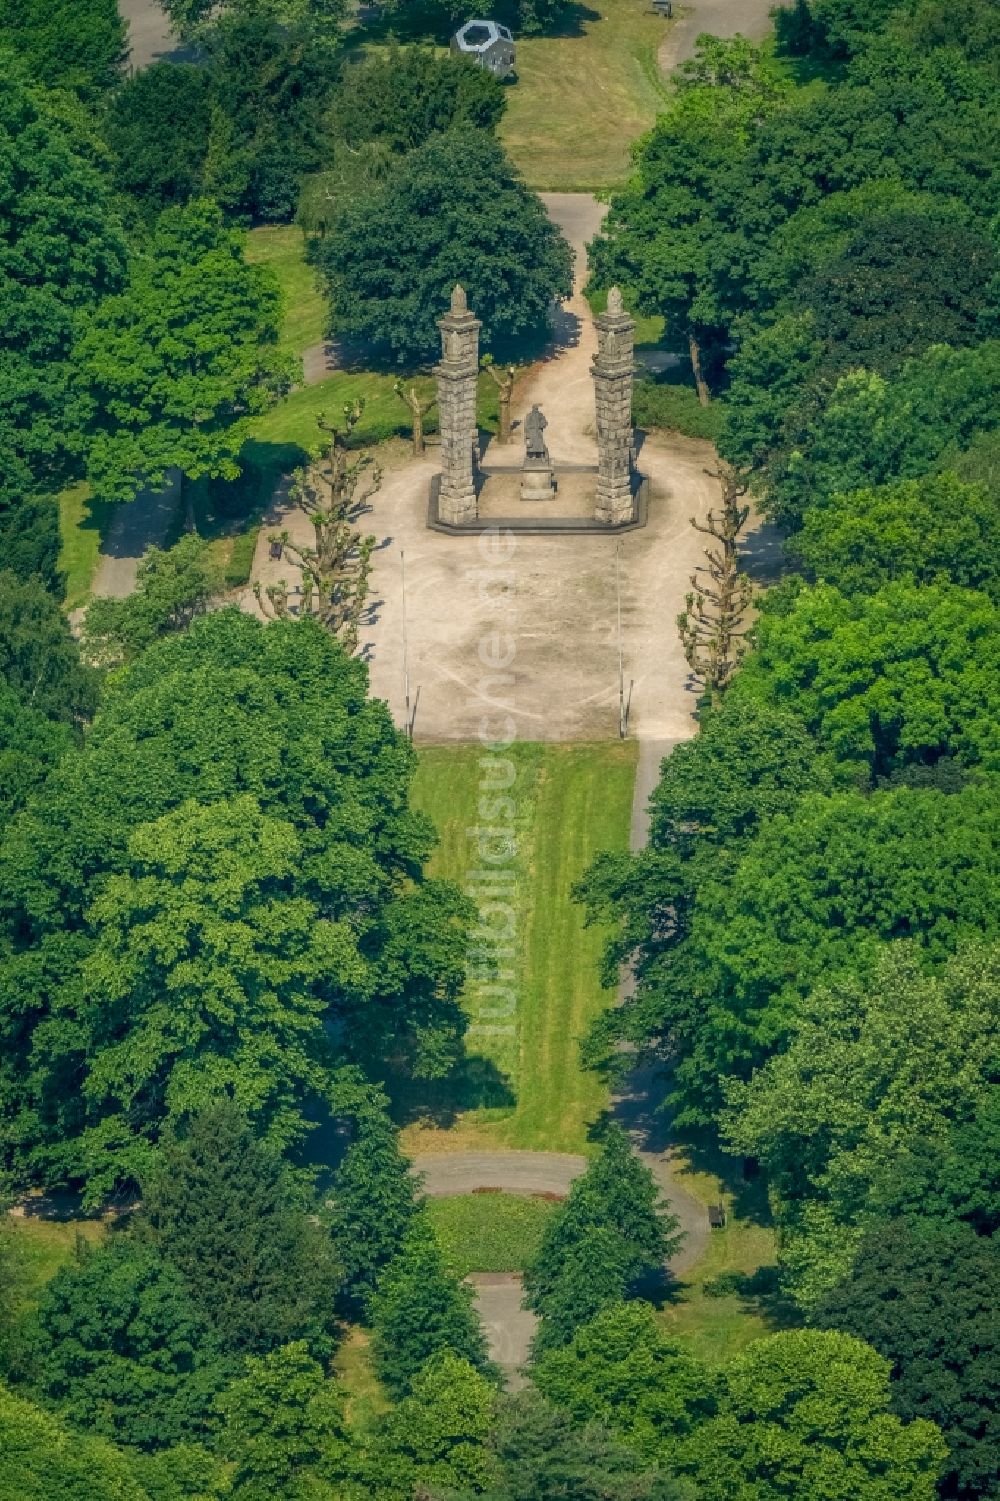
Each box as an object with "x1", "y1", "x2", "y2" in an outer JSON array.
[{"x1": 590, "y1": 287, "x2": 635, "y2": 524}]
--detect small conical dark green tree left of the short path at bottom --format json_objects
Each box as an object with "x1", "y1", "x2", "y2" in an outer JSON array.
[{"x1": 371, "y1": 1216, "x2": 492, "y2": 1396}]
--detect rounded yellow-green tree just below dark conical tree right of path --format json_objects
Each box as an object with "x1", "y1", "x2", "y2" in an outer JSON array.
[{"x1": 532, "y1": 1301, "x2": 716, "y2": 1468}]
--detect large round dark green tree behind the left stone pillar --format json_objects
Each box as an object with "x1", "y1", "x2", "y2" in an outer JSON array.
[{"x1": 315, "y1": 128, "x2": 572, "y2": 365}]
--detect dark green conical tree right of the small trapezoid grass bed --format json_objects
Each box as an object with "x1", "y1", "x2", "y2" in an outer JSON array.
[{"x1": 524, "y1": 1126, "x2": 682, "y2": 1351}]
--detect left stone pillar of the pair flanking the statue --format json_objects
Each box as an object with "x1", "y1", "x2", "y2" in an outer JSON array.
[{"x1": 434, "y1": 287, "x2": 482, "y2": 525}]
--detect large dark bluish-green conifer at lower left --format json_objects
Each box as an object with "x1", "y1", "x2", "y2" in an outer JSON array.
[{"x1": 141, "y1": 1097, "x2": 339, "y2": 1357}]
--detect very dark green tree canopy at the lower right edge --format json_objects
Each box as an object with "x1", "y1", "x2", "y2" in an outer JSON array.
[{"x1": 815, "y1": 1219, "x2": 1000, "y2": 1501}]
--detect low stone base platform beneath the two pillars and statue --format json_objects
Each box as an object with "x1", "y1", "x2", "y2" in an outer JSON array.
[{"x1": 426, "y1": 464, "x2": 649, "y2": 537}]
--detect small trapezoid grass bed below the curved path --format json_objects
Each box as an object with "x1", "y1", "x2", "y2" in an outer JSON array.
[{"x1": 426, "y1": 1193, "x2": 556, "y2": 1277}]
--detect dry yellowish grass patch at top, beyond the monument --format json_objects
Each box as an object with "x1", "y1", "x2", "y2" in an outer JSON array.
[{"x1": 500, "y1": 0, "x2": 670, "y2": 192}]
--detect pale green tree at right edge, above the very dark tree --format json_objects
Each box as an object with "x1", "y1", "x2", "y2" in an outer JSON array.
[{"x1": 725, "y1": 944, "x2": 1000, "y2": 1304}]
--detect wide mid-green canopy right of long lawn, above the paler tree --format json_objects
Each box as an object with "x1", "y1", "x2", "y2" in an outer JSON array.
[{"x1": 593, "y1": 781, "x2": 1000, "y2": 1121}]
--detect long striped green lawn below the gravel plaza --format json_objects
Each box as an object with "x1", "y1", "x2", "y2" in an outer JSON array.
[{"x1": 407, "y1": 741, "x2": 635, "y2": 1151}]
